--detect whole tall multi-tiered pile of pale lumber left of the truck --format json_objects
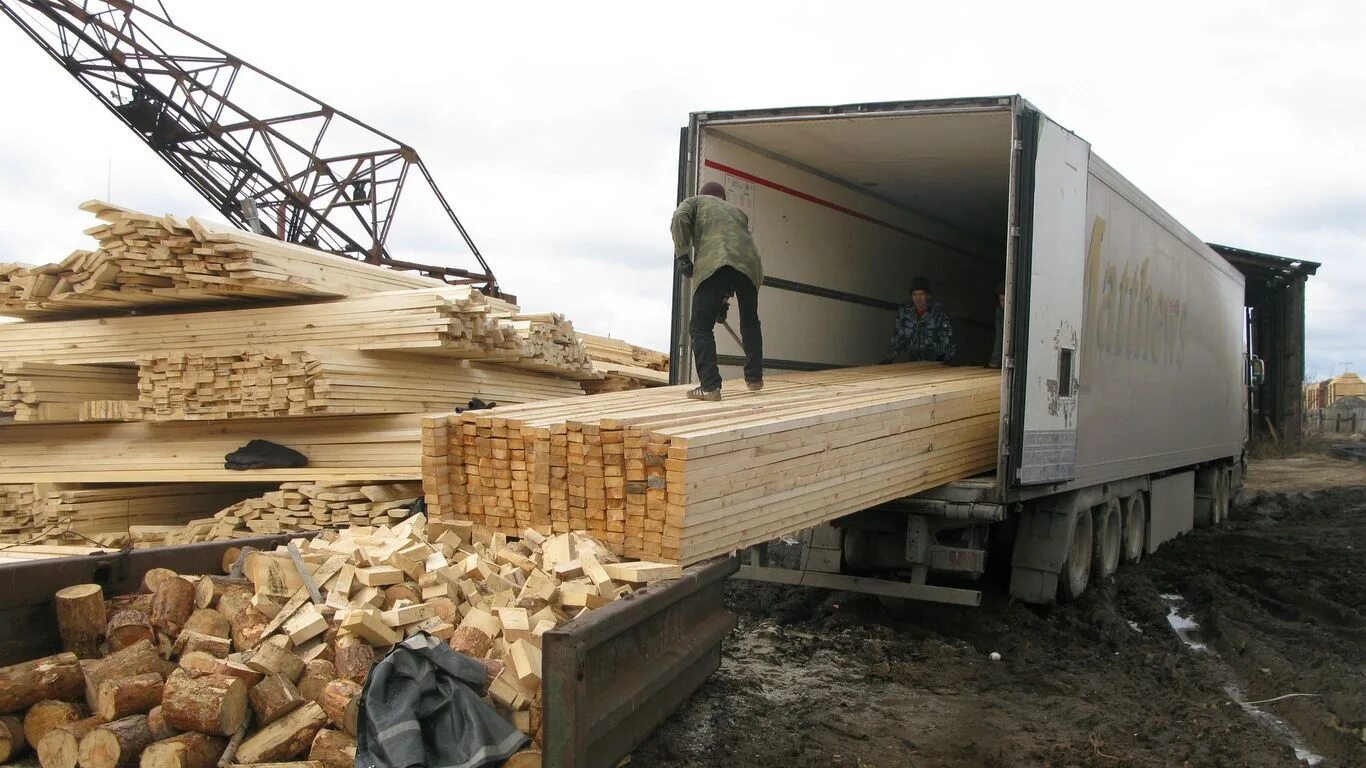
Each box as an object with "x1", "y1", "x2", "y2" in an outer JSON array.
[{"x1": 0, "y1": 201, "x2": 668, "y2": 549}]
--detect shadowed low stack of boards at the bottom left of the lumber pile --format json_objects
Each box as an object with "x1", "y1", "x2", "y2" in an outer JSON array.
[{"x1": 33, "y1": 482, "x2": 275, "y2": 547}]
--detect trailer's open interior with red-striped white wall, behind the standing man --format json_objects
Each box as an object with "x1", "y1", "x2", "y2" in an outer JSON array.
[{"x1": 690, "y1": 109, "x2": 1012, "y2": 377}]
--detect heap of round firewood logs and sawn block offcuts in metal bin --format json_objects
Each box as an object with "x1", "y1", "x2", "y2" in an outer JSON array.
[{"x1": 0, "y1": 517, "x2": 679, "y2": 768}]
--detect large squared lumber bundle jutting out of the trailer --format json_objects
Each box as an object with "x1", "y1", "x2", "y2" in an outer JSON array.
[{"x1": 422, "y1": 364, "x2": 1000, "y2": 564}]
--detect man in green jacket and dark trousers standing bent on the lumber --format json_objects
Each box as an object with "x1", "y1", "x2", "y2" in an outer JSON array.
[{"x1": 671, "y1": 182, "x2": 764, "y2": 400}]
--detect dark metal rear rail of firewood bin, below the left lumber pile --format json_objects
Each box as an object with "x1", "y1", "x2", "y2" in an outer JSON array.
[{"x1": 0, "y1": 533, "x2": 302, "y2": 667}]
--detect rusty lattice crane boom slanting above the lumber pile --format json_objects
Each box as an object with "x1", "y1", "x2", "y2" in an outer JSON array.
[{"x1": 0, "y1": 0, "x2": 497, "y2": 292}]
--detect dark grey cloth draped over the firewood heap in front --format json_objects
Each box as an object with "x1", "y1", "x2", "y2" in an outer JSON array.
[{"x1": 355, "y1": 631, "x2": 531, "y2": 768}]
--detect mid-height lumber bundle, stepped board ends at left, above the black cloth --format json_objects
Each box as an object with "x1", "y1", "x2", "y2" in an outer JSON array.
[{"x1": 137, "y1": 348, "x2": 582, "y2": 421}]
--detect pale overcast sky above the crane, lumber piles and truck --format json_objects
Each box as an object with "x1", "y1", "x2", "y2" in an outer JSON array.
[{"x1": 0, "y1": 0, "x2": 1366, "y2": 376}]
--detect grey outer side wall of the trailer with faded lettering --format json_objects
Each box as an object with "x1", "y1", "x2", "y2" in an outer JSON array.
[{"x1": 1070, "y1": 154, "x2": 1246, "y2": 486}]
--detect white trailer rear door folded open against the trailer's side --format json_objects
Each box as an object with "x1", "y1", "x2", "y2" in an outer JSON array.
[{"x1": 1009, "y1": 108, "x2": 1090, "y2": 485}]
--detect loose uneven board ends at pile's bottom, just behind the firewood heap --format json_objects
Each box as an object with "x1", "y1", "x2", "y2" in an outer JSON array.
[{"x1": 142, "y1": 482, "x2": 422, "y2": 545}]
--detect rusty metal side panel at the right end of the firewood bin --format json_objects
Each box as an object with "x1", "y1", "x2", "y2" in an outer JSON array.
[{"x1": 541, "y1": 558, "x2": 739, "y2": 768}]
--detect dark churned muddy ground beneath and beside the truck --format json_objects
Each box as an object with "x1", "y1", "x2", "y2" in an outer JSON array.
[{"x1": 631, "y1": 458, "x2": 1366, "y2": 768}]
